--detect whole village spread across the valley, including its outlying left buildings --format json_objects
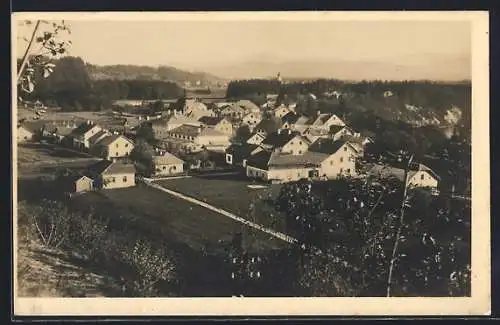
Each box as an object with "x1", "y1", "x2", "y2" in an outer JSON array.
[{"x1": 17, "y1": 76, "x2": 440, "y2": 197}]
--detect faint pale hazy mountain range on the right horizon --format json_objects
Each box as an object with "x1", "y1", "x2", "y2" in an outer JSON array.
[{"x1": 193, "y1": 57, "x2": 471, "y2": 81}]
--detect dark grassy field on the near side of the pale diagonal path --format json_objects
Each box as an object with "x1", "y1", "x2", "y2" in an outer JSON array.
[{"x1": 73, "y1": 186, "x2": 284, "y2": 252}]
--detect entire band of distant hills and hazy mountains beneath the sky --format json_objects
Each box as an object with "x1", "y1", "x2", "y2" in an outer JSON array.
[{"x1": 87, "y1": 56, "x2": 471, "y2": 86}]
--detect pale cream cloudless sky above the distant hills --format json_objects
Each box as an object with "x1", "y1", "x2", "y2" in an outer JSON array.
[{"x1": 14, "y1": 20, "x2": 471, "y2": 79}]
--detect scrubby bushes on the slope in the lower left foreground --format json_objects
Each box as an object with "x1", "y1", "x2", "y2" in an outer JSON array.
[{"x1": 19, "y1": 200, "x2": 180, "y2": 296}]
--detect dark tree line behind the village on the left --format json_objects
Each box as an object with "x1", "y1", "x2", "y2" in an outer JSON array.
[{"x1": 18, "y1": 57, "x2": 183, "y2": 111}]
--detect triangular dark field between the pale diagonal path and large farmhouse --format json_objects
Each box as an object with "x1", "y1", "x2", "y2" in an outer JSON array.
[{"x1": 158, "y1": 175, "x2": 290, "y2": 232}]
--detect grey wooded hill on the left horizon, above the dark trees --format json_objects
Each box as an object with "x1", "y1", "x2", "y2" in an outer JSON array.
[{"x1": 87, "y1": 64, "x2": 225, "y2": 86}]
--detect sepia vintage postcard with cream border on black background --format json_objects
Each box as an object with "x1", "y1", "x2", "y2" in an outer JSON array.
[{"x1": 12, "y1": 11, "x2": 491, "y2": 316}]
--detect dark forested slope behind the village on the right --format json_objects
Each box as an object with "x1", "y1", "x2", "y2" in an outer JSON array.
[{"x1": 227, "y1": 79, "x2": 471, "y2": 130}]
